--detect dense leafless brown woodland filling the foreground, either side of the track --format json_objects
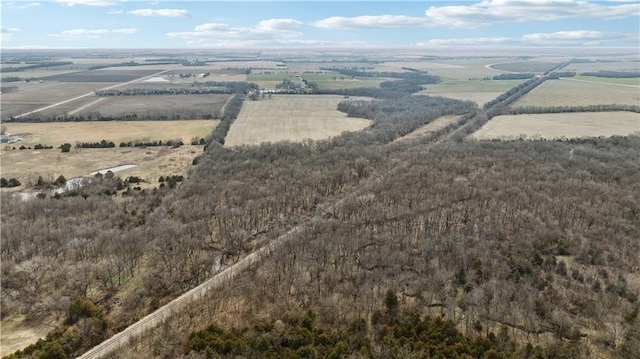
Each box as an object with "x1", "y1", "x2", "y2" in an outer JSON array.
[{"x1": 0, "y1": 66, "x2": 640, "y2": 358}]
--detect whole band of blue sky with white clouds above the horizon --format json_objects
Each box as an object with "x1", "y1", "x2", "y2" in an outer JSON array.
[{"x1": 0, "y1": 0, "x2": 640, "y2": 49}]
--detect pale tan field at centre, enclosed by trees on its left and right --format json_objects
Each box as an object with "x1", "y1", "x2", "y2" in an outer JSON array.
[{"x1": 225, "y1": 95, "x2": 371, "y2": 147}]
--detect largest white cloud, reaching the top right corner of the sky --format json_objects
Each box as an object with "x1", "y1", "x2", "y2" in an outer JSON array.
[{"x1": 425, "y1": 0, "x2": 640, "y2": 28}]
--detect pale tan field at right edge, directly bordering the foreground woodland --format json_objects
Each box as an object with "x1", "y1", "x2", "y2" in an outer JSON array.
[{"x1": 470, "y1": 111, "x2": 640, "y2": 140}]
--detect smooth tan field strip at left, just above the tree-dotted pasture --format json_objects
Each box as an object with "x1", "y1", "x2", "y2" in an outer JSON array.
[{"x1": 2, "y1": 120, "x2": 218, "y2": 147}]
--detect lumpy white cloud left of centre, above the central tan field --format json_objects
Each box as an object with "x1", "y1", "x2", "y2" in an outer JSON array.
[{"x1": 167, "y1": 19, "x2": 302, "y2": 44}]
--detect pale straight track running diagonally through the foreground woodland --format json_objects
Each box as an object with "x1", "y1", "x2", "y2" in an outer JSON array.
[{"x1": 78, "y1": 225, "x2": 304, "y2": 359}]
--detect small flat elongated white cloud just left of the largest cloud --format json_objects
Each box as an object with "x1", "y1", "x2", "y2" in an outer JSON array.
[{"x1": 311, "y1": 15, "x2": 428, "y2": 30}]
